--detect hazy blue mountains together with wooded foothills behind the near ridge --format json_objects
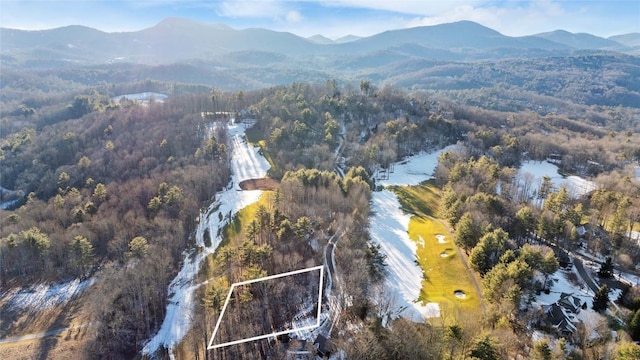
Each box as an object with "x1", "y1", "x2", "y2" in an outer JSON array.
[{"x1": 0, "y1": 18, "x2": 640, "y2": 113}]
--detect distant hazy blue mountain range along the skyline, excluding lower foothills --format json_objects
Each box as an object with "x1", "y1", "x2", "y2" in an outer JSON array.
[{"x1": 0, "y1": 18, "x2": 640, "y2": 67}]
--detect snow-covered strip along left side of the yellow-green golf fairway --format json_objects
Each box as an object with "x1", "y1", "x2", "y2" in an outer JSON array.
[{"x1": 370, "y1": 146, "x2": 455, "y2": 322}]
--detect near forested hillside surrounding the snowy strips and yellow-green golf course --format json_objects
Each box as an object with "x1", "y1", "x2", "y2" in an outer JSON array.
[{"x1": 0, "y1": 80, "x2": 640, "y2": 359}]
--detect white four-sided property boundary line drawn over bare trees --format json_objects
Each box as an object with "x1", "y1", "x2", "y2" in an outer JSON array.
[{"x1": 207, "y1": 265, "x2": 324, "y2": 350}]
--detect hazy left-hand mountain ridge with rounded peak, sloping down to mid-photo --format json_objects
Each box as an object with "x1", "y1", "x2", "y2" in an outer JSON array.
[{"x1": 0, "y1": 18, "x2": 315, "y2": 64}]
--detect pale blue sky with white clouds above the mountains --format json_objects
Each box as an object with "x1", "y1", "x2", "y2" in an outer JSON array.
[{"x1": 0, "y1": 0, "x2": 640, "y2": 40}]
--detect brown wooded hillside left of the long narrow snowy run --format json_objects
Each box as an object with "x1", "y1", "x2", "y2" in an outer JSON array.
[{"x1": 0, "y1": 88, "x2": 229, "y2": 356}]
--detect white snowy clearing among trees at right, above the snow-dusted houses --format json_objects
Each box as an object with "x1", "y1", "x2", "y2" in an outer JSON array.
[{"x1": 519, "y1": 160, "x2": 597, "y2": 198}]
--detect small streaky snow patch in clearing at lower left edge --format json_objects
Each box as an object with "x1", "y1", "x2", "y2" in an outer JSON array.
[{"x1": 0, "y1": 278, "x2": 95, "y2": 311}]
